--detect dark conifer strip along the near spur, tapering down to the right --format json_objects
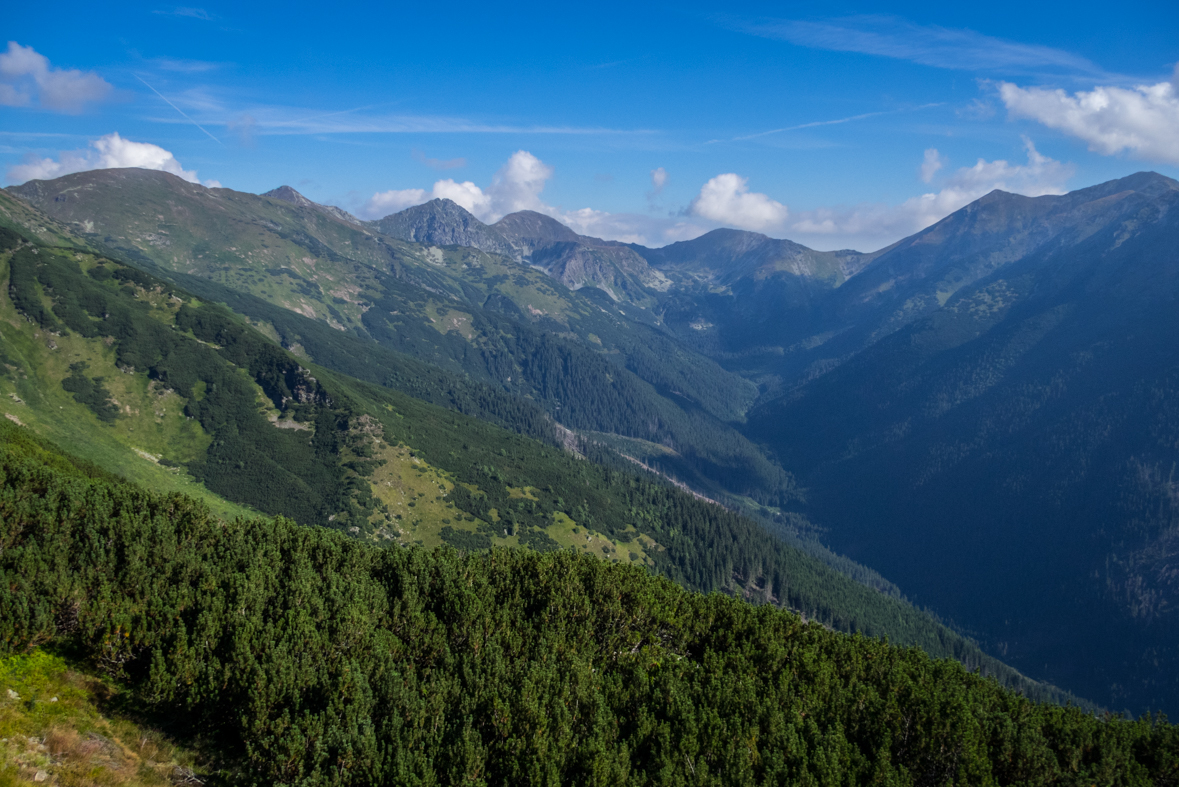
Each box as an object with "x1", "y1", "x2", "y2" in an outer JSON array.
[{"x1": 320, "y1": 372, "x2": 1074, "y2": 701}]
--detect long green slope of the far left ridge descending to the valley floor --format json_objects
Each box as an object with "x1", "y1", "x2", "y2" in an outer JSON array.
[{"x1": 6, "y1": 170, "x2": 820, "y2": 505}]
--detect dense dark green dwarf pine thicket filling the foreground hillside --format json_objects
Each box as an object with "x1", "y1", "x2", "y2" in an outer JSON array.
[{"x1": 0, "y1": 447, "x2": 1179, "y2": 786}]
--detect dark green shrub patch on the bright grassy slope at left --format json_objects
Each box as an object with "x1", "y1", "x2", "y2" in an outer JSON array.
[{"x1": 12, "y1": 249, "x2": 373, "y2": 527}]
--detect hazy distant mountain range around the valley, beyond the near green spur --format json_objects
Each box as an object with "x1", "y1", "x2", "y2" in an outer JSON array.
[{"x1": 9, "y1": 170, "x2": 1179, "y2": 713}]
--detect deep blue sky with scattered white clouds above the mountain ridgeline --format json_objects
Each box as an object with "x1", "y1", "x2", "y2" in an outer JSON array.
[{"x1": 0, "y1": 2, "x2": 1179, "y2": 250}]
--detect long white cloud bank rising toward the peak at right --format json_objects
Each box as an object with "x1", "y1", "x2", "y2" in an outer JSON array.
[{"x1": 790, "y1": 137, "x2": 1074, "y2": 250}]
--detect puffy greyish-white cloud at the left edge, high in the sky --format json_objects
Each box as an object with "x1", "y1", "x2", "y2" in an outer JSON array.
[{"x1": 0, "y1": 41, "x2": 113, "y2": 113}]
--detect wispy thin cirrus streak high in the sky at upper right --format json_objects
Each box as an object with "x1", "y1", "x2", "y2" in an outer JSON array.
[{"x1": 722, "y1": 14, "x2": 1109, "y2": 79}]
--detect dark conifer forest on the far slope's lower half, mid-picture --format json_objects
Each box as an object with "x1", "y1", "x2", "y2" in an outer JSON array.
[{"x1": 360, "y1": 282, "x2": 798, "y2": 505}]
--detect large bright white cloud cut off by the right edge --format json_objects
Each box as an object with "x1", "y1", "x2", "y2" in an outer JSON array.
[{"x1": 999, "y1": 79, "x2": 1179, "y2": 164}]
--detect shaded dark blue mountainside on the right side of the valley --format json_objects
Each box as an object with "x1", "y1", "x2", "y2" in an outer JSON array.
[{"x1": 750, "y1": 179, "x2": 1179, "y2": 709}]
